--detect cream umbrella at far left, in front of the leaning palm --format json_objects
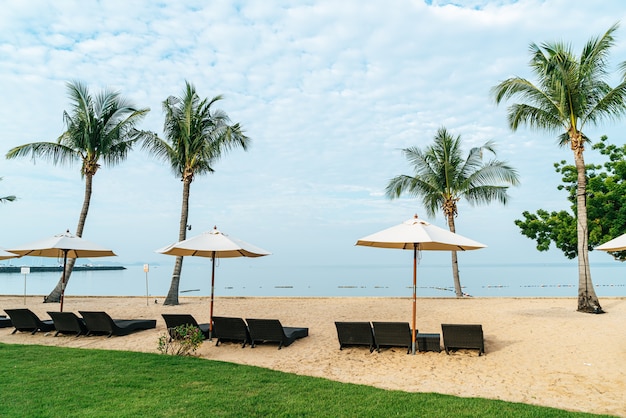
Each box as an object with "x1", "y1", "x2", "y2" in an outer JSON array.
[{"x1": 9, "y1": 231, "x2": 115, "y2": 312}]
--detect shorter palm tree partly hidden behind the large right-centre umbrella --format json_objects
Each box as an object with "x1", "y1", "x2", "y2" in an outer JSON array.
[{"x1": 386, "y1": 127, "x2": 519, "y2": 298}]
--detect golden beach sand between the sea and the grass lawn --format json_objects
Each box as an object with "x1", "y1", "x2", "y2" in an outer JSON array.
[{"x1": 0, "y1": 296, "x2": 626, "y2": 417}]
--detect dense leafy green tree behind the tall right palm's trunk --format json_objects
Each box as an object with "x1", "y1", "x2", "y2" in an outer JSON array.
[{"x1": 515, "y1": 137, "x2": 626, "y2": 261}]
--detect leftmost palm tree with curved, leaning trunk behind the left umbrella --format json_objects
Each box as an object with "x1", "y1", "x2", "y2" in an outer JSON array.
[{"x1": 6, "y1": 81, "x2": 150, "y2": 302}]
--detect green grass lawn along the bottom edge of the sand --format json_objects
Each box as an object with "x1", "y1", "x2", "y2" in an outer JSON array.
[{"x1": 0, "y1": 344, "x2": 612, "y2": 418}]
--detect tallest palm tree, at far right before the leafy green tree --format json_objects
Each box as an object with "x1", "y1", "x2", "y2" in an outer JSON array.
[{"x1": 492, "y1": 24, "x2": 626, "y2": 313}]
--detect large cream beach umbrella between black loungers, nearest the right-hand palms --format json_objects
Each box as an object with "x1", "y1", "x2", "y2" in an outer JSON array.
[{"x1": 356, "y1": 215, "x2": 486, "y2": 354}]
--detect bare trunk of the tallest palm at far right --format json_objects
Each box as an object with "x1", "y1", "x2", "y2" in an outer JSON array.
[{"x1": 574, "y1": 150, "x2": 604, "y2": 313}]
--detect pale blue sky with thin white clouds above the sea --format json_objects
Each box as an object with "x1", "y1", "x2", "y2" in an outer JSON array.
[{"x1": 0, "y1": 0, "x2": 626, "y2": 268}]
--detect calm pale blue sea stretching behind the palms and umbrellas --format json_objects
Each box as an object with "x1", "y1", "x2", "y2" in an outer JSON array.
[{"x1": 0, "y1": 260, "x2": 626, "y2": 300}]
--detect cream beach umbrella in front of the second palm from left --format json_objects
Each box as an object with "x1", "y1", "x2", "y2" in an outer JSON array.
[{"x1": 157, "y1": 227, "x2": 271, "y2": 339}]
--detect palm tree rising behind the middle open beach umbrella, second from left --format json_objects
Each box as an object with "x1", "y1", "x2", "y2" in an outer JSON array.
[{"x1": 143, "y1": 82, "x2": 250, "y2": 305}]
